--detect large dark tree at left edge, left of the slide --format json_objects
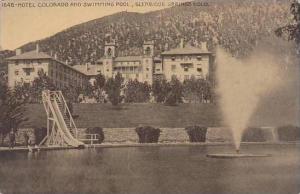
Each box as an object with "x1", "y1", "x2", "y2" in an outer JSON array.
[{"x1": 0, "y1": 74, "x2": 27, "y2": 145}]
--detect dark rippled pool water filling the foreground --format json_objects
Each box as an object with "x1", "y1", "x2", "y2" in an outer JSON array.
[{"x1": 0, "y1": 145, "x2": 300, "y2": 194}]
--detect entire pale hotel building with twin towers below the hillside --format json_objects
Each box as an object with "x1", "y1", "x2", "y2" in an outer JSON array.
[{"x1": 7, "y1": 41, "x2": 212, "y2": 88}]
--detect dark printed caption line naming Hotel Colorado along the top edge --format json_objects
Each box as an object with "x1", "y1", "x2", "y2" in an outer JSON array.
[{"x1": 0, "y1": 0, "x2": 208, "y2": 8}]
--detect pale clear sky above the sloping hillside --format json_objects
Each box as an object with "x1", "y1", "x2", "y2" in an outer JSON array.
[{"x1": 0, "y1": 0, "x2": 178, "y2": 50}]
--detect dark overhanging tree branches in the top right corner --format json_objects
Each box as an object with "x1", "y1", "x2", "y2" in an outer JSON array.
[{"x1": 275, "y1": 0, "x2": 300, "y2": 52}]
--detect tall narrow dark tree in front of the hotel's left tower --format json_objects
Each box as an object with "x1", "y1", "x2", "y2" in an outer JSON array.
[{"x1": 104, "y1": 73, "x2": 124, "y2": 106}]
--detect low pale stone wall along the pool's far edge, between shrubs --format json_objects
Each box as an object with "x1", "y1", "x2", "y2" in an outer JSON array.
[{"x1": 5, "y1": 127, "x2": 298, "y2": 145}]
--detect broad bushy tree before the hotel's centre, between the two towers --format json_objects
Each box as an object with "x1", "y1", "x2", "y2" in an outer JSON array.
[{"x1": 124, "y1": 80, "x2": 151, "y2": 103}]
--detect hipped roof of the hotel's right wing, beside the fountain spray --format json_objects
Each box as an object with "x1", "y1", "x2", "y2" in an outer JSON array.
[{"x1": 161, "y1": 46, "x2": 211, "y2": 55}]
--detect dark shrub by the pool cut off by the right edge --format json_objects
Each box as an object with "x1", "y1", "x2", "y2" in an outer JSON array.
[{"x1": 277, "y1": 125, "x2": 300, "y2": 141}]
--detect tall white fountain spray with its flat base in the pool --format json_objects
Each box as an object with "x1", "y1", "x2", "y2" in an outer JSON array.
[{"x1": 208, "y1": 48, "x2": 281, "y2": 158}]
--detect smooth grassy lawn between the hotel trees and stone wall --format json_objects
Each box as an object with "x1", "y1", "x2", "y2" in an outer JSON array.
[{"x1": 22, "y1": 104, "x2": 221, "y2": 128}]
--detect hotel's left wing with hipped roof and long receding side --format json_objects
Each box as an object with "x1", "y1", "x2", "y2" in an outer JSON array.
[{"x1": 7, "y1": 46, "x2": 88, "y2": 89}]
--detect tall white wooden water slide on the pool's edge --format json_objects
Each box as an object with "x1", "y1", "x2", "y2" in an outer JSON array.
[{"x1": 40, "y1": 90, "x2": 84, "y2": 148}]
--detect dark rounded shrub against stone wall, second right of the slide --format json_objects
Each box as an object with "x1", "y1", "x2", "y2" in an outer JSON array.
[{"x1": 135, "y1": 126, "x2": 160, "y2": 143}]
